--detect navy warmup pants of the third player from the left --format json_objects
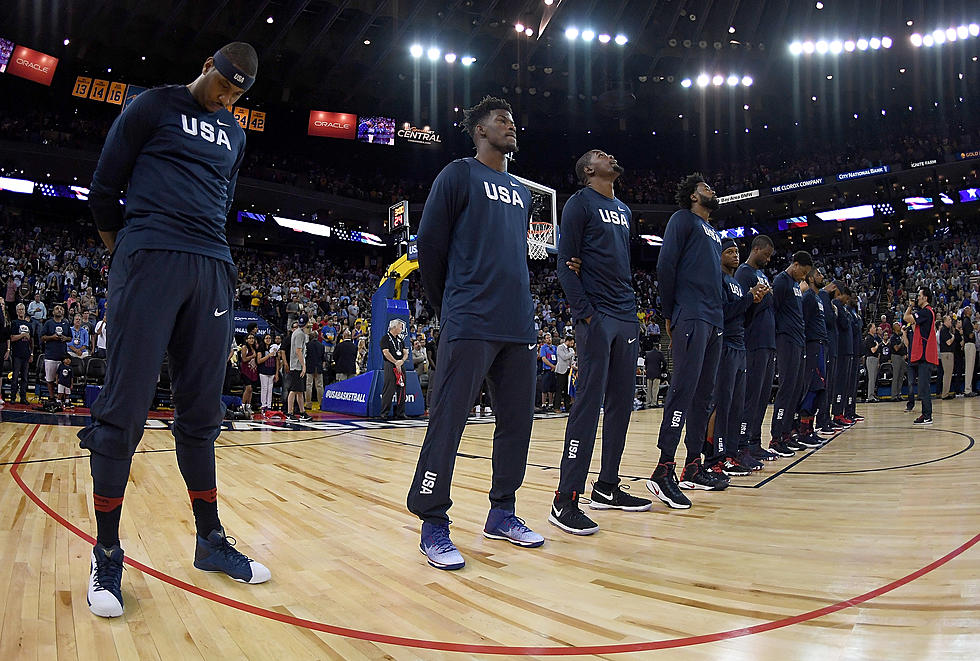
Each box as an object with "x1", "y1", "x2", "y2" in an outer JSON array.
[{"x1": 558, "y1": 312, "x2": 640, "y2": 494}]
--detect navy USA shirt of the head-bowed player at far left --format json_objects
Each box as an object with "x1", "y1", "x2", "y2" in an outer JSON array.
[{"x1": 89, "y1": 85, "x2": 245, "y2": 263}]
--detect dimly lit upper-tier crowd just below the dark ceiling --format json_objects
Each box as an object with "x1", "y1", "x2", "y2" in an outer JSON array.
[{"x1": 0, "y1": 108, "x2": 980, "y2": 205}]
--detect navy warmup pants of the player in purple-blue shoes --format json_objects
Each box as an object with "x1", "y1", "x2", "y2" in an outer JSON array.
[{"x1": 408, "y1": 339, "x2": 536, "y2": 525}]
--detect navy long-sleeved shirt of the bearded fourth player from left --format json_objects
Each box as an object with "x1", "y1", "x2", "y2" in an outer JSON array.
[{"x1": 657, "y1": 209, "x2": 725, "y2": 328}]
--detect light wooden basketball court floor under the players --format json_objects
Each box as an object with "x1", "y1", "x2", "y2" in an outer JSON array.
[{"x1": 0, "y1": 399, "x2": 980, "y2": 661}]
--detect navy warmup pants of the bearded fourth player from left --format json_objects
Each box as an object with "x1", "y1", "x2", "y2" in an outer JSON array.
[{"x1": 657, "y1": 319, "x2": 722, "y2": 457}]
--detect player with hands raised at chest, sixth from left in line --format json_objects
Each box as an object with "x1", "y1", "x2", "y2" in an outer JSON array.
[{"x1": 735, "y1": 234, "x2": 779, "y2": 461}]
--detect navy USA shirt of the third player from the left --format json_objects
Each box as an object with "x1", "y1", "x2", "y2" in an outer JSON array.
[{"x1": 558, "y1": 187, "x2": 637, "y2": 321}]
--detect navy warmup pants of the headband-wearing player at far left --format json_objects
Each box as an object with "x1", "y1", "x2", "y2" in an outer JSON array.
[{"x1": 78, "y1": 250, "x2": 237, "y2": 462}]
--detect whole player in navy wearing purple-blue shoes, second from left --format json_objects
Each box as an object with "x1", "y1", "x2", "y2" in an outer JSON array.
[{"x1": 408, "y1": 96, "x2": 544, "y2": 569}]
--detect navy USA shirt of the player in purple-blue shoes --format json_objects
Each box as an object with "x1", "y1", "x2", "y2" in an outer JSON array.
[{"x1": 417, "y1": 158, "x2": 538, "y2": 344}]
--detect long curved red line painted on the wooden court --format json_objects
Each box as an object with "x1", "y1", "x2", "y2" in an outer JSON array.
[{"x1": 10, "y1": 425, "x2": 980, "y2": 656}]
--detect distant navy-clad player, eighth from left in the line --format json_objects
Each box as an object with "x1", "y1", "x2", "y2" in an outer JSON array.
[{"x1": 797, "y1": 266, "x2": 833, "y2": 448}]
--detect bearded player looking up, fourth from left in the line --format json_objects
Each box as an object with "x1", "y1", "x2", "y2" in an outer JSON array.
[{"x1": 646, "y1": 173, "x2": 728, "y2": 509}]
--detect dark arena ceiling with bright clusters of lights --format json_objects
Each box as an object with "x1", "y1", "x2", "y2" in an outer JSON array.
[{"x1": 0, "y1": 0, "x2": 980, "y2": 129}]
